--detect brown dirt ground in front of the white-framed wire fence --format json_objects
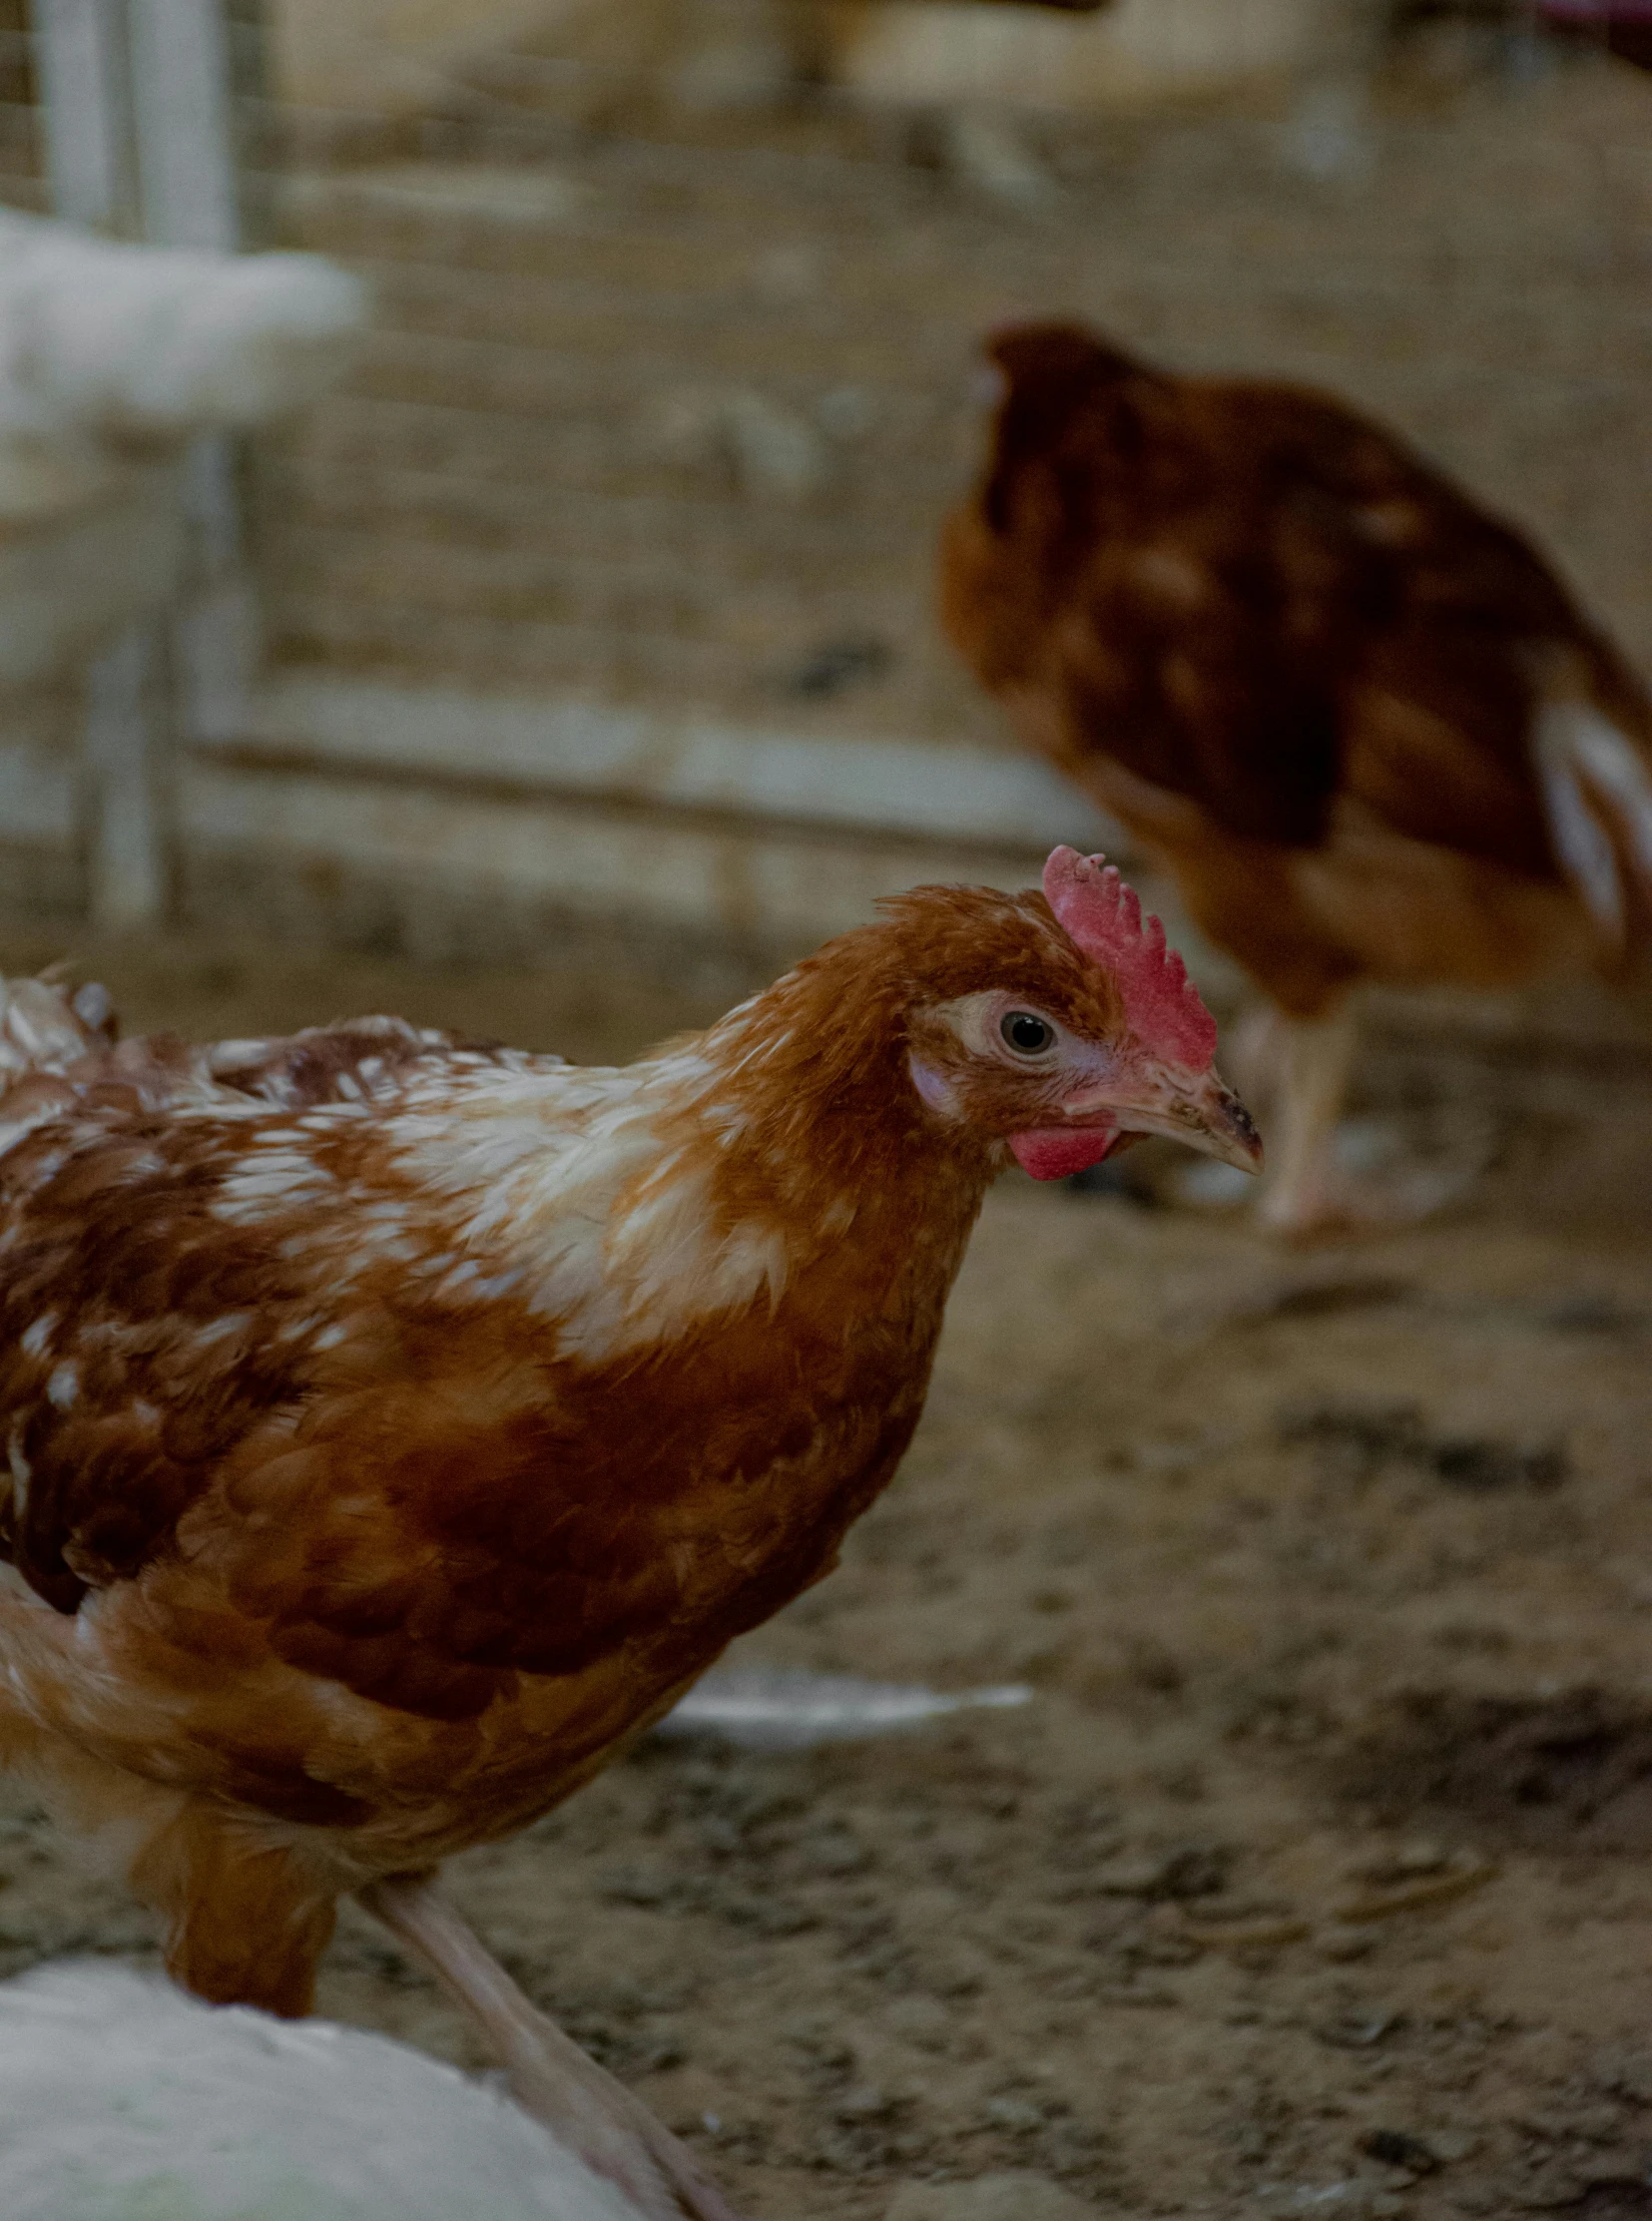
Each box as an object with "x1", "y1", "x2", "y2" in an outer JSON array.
[{"x1": 0, "y1": 948, "x2": 1652, "y2": 2221}]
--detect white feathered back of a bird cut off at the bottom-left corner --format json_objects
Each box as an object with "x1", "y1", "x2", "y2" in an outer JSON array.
[{"x1": 0, "y1": 1961, "x2": 640, "y2": 2221}]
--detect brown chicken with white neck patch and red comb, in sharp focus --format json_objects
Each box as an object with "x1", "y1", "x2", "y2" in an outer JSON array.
[{"x1": 0, "y1": 848, "x2": 1259, "y2": 2221}]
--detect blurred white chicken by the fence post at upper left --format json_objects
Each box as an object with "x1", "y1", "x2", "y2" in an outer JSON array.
[{"x1": 0, "y1": 211, "x2": 366, "y2": 691}]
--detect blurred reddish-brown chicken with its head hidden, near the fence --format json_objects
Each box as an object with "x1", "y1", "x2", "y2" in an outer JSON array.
[{"x1": 941, "y1": 324, "x2": 1652, "y2": 1233}]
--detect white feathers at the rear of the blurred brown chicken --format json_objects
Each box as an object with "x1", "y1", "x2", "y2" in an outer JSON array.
[{"x1": 1532, "y1": 700, "x2": 1652, "y2": 950}]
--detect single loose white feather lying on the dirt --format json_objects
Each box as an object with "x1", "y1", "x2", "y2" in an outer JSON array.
[{"x1": 657, "y1": 1666, "x2": 1032, "y2": 1750}]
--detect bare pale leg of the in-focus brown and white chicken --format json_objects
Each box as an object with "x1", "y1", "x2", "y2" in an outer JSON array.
[{"x1": 368, "y1": 1875, "x2": 740, "y2": 2221}]
